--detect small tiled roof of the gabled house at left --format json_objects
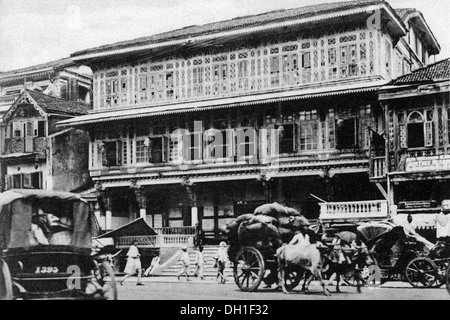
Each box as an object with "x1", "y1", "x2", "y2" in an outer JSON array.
[{"x1": 27, "y1": 90, "x2": 90, "y2": 116}]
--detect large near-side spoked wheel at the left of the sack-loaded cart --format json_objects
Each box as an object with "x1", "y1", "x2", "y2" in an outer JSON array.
[{"x1": 233, "y1": 247, "x2": 266, "y2": 292}]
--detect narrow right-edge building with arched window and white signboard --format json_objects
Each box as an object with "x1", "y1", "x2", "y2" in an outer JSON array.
[{"x1": 380, "y1": 59, "x2": 450, "y2": 238}]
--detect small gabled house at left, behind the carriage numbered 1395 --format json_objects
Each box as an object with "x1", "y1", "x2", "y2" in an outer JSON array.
[{"x1": 0, "y1": 89, "x2": 90, "y2": 191}]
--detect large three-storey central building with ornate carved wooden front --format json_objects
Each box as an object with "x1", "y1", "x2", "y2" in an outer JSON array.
[{"x1": 58, "y1": 1, "x2": 440, "y2": 238}]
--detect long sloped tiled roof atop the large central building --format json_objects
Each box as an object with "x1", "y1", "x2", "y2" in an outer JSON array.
[{"x1": 71, "y1": 0, "x2": 386, "y2": 57}]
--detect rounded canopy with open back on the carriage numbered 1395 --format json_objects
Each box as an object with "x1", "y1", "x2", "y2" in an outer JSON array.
[{"x1": 0, "y1": 190, "x2": 92, "y2": 250}]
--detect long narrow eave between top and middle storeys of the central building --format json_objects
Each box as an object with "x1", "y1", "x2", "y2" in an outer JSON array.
[{"x1": 57, "y1": 80, "x2": 386, "y2": 127}]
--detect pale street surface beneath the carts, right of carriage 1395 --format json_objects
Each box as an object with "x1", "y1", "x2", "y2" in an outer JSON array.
[{"x1": 118, "y1": 278, "x2": 450, "y2": 301}]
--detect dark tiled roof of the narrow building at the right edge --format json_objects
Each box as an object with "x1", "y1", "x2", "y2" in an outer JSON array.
[{"x1": 390, "y1": 58, "x2": 450, "y2": 85}]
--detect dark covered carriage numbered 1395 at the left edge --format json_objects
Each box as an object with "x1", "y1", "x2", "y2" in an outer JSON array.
[{"x1": 0, "y1": 190, "x2": 117, "y2": 299}]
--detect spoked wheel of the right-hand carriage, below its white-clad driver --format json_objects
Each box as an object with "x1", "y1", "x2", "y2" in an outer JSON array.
[{"x1": 405, "y1": 258, "x2": 439, "y2": 288}]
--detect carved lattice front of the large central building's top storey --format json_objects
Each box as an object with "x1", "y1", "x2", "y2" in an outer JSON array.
[{"x1": 94, "y1": 29, "x2": 379, "y2": 110}]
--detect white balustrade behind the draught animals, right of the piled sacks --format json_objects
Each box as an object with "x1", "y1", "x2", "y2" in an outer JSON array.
[{"x1": 319, "y1": 200, "x2": 388, "y2": 220}]
